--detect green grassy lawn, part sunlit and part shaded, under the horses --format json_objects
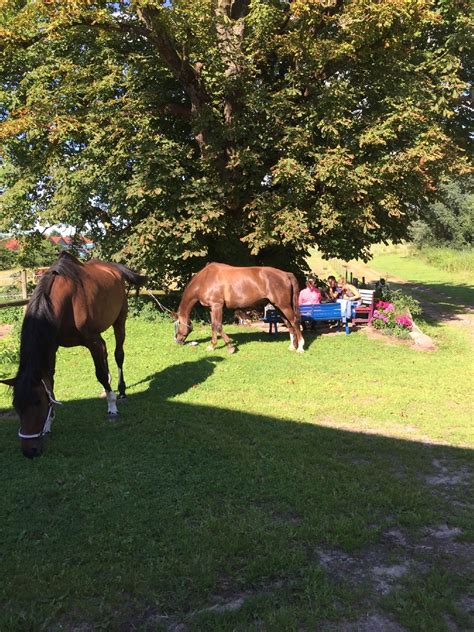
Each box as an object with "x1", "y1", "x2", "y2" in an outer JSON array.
[{"x1": 0, "y1": 254, "x2": 474, "y2": 632}]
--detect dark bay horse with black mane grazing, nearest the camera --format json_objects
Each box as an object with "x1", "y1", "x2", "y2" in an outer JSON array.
[{"x1": 0, "y1": 252, "x2": 145, "y2": 458}]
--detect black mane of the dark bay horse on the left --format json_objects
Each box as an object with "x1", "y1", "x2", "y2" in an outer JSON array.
[{"x1": 13, "y1": 252, "x2": 82, "y2": 412}]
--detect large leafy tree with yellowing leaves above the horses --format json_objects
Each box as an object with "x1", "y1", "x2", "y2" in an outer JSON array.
[{"x1": 0, "y1": 0, "x2": 470, "y2": 283}]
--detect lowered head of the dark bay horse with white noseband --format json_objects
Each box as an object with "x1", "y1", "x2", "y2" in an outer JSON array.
[{"x1": 0, "y1": 378, "x2": 61, "y2": 459}]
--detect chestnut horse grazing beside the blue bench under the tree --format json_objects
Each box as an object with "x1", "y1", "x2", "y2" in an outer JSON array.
[{"x1": 174, "y1": 263, "x2": 304, "y2": 353}]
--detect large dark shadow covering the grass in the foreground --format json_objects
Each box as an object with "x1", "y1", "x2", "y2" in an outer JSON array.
[{"x1": 0, "y1": 357, "x2": 472, "y2": 630}]
